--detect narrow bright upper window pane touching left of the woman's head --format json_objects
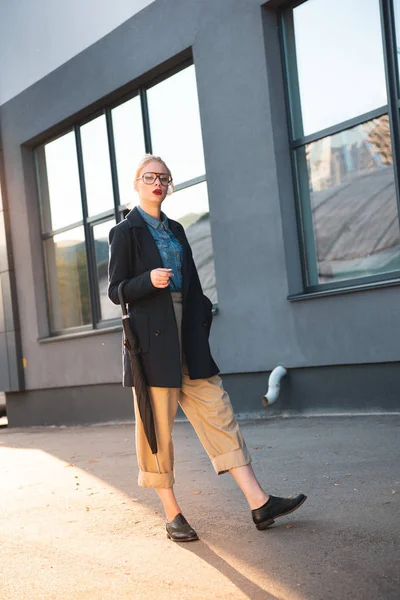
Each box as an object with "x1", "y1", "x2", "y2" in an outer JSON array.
[{"x1": 111, "y1": 97, "x2": 145, "y2": 206}]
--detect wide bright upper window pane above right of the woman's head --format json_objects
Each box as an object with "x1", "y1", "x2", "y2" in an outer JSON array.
[{"x1": 147, "y1": 66, "x2": 205, "y2": 184}]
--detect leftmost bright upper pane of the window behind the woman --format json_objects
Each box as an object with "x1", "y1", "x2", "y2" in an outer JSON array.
[{"x1": 36, "y1": 131, "x2": 82, "y2": 232}]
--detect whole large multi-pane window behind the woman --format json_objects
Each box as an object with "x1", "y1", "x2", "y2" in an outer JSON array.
[{"x1": 35, "y1": 66, "x2": 217, "y2": 334}]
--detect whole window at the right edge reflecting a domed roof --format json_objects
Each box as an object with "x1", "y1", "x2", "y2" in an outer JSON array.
[{"x1": 282, "y1": 0, "x2": 400, "y2": 291}]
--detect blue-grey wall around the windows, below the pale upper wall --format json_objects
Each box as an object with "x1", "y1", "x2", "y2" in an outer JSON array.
[{"x1": 0, "y1": 0, "x2": 400, "y2": 408}]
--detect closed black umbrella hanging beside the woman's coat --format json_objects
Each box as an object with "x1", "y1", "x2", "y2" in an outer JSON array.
[{"x1": 118, "y1": 279, "x2": 160, "y2": 462}]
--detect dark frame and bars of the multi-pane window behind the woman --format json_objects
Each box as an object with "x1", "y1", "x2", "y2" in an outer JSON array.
[{"x1": 36, "y1": 58, "x2": 207, "y2": 341}]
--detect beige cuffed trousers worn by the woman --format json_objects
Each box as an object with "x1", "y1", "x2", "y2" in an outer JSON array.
[{"x1": 132, "y1": 292, "x2": 251, "y2": 488}]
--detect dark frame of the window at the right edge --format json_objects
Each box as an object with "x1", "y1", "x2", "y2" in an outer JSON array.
[{"x1": 278, "y1": 0, "x2": 400, "y2": 300}]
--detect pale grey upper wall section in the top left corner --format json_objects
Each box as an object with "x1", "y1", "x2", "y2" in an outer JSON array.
[{"x1": 0, "y1": 0, "x2": 153, "y2": 105}]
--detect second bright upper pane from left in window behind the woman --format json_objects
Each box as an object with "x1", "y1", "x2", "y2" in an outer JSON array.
[{"x1": 81, "y1": 115, "x2": 114, "y2": 216}]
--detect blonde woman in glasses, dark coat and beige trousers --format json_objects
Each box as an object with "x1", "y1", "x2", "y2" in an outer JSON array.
[{"x1": 108, "y1": 154, "x2": 306, "y2": 542}]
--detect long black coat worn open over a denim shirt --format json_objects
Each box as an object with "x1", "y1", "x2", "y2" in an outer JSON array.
[{"x1": 108, "y1": 208, "x2": 219, "y2": 387}]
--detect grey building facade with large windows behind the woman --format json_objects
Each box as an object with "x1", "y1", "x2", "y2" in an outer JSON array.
[{"x1": 0, "y1": 0, "x2": 400, "y2": 426}]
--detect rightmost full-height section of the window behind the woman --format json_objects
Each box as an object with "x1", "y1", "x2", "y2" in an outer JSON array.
[{"x1": 147, "y1": 66, "x2": 217, "y2": 303}]
